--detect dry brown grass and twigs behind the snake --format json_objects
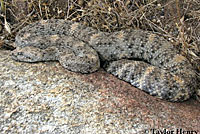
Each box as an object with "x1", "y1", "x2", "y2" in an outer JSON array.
[{"x1": 0, "y1": 0, "x2": 200, "y2": 73}]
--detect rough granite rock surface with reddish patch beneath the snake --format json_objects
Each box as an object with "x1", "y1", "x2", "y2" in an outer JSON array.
[{"x1": 0, "y1": 50, "x2": 200, "y2": 134}]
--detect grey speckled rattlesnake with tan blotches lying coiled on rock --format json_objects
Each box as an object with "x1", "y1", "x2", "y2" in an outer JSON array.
[{"x1": 11, "y1": 19, "x2": 200, "y2": 101}]
